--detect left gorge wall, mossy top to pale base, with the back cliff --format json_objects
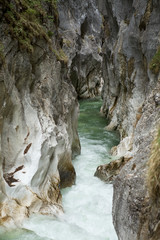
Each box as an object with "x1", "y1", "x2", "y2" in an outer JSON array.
[{"x1": 0, "y1": 0, "x2": 102, "y2": 227}]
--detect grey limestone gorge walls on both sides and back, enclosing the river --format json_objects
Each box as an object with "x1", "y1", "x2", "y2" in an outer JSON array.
[{"x1": 0, "y1": 0, "x2": 160, "y2": 236}]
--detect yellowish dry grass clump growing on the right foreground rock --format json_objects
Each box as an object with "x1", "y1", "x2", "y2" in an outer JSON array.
[{"x1": 147, "y1": 128, "x2": 160, "y2": 207}]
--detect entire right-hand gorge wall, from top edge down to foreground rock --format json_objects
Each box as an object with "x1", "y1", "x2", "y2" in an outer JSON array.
[{"x1": 97, "y1": 0, "x2": 160, "y2": 240}]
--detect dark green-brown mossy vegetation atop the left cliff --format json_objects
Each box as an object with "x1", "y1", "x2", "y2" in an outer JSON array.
[{"x1": 0, "y1": 0, "x2": 58, "y2": 52}]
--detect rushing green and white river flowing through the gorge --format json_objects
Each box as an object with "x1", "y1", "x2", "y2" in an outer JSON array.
[{"x1": 0, "y1": 100, "x2": 118, "y2": 240}]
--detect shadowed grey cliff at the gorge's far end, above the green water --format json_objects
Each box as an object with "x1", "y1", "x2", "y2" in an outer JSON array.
[{"x1": 58, "y1": 0, "x2": 103, "y2": 98}]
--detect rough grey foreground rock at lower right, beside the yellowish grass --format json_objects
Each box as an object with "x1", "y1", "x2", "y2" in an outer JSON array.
[{"x1": 113, "y1": 83, "x2": 160, "y2": 240}]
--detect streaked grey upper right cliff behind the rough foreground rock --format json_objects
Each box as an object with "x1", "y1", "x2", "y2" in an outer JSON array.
[{"x1": 98, "y1": 0, "x2": 160, "y2": 138}]
